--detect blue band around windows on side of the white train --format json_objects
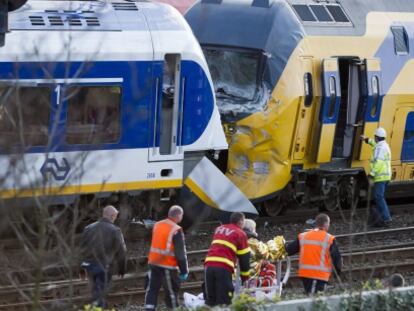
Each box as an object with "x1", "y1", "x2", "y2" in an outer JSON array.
[{"x1": 0, "y1": 61, "x2": 214, "y2": 153}]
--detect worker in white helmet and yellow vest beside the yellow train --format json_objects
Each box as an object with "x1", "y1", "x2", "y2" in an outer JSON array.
[{"x1": 361, "y1": 127, "x2": 392, "y2": 227}]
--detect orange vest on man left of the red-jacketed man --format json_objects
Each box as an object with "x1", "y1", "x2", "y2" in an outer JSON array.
[{"x1": 148, "y1": 219, "x2": 182, "y2": 269}]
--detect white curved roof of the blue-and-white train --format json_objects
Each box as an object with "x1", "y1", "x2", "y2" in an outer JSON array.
[{"x1": 0, "y1": 0, "x2": 203, "y2": 61}]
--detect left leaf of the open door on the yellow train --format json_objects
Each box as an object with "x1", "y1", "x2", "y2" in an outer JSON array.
[{"x1": 316, "y1": 58, "x2": 341, "y2": 163}]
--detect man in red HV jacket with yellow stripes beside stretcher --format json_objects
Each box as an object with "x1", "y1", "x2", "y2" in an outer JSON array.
[{"x1": 204, "y1": 213, "x2": 250, "y2": 306}]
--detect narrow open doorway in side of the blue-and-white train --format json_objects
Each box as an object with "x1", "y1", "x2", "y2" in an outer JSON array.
[{"x1": 149, "y1": 54, "x2": 183, "y2": 161}]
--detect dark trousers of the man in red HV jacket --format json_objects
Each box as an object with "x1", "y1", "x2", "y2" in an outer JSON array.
[{"x1": 204, "y1": 267, "x2": 234, "y2": 307}]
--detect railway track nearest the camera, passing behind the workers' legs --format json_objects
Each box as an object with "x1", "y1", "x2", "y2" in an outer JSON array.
[{"x1": 0, "y1": 246, "x2": 414, "y2": 310}]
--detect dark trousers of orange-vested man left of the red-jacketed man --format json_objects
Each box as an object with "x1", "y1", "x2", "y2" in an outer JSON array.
[{"x1": 144, "y1": 265, "x2": 180, "y2": 310}]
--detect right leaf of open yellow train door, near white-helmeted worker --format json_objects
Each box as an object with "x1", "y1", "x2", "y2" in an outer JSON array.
[{"x1": 359, "y1": 59, "x2": 383, "y2": 161}]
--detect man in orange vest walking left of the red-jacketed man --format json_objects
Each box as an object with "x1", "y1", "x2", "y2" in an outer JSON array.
[{"x1": 144, "y1": 205, "x2": 188, "y2": 310}]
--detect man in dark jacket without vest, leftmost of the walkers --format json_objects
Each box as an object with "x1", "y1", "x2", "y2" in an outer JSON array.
[{"x1": 81, "y1": 205, "x2": 126, "y2": 308}]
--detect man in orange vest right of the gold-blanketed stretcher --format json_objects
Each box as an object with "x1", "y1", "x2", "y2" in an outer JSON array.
[{"x1": 286, "y1": 214, "x2": 342, "y2": 295}]
